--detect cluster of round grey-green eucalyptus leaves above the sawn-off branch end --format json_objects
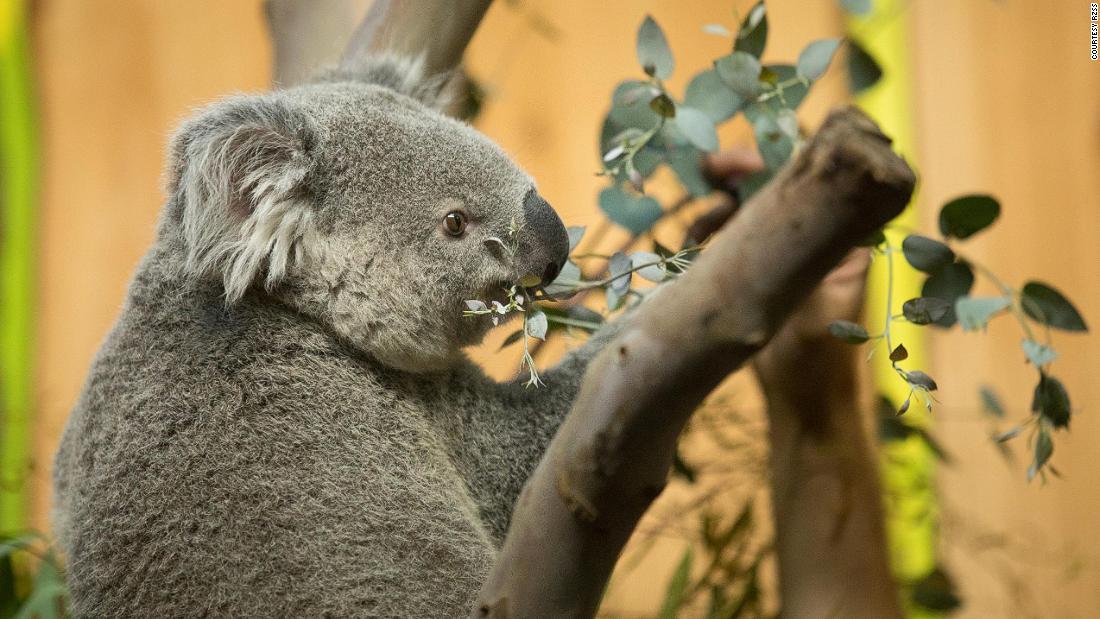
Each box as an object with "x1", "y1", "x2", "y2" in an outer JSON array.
[{"x1": 600, "y1": 1, "x2": 836, "y2": 235}]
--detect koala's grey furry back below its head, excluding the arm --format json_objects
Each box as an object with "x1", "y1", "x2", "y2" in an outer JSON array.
[{"x1": 55, "y1": 250, "x2": 494, "y2": 617}]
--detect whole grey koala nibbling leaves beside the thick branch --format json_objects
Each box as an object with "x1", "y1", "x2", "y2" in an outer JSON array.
[{"x1": 54, "y1": 57, "x2": 617, "y2": 617}]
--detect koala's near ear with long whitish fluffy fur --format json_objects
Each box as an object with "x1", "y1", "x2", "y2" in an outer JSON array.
[{"x1": 169, "y1": 97, "x2": 316, "y2": 303}]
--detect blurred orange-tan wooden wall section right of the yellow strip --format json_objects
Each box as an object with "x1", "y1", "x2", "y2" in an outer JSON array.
[{"x1": 912, "y1": 0, "x2": 1100, "y2": 618}]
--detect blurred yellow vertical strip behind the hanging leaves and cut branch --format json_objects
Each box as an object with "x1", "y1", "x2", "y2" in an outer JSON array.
[{"x1": 850, "y1": 0, "x2": 938, "y2": 617}]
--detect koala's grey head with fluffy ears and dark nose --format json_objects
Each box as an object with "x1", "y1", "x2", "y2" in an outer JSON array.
[{"x1": 169, "y1": 58, "x2": 569, "y2": 372}]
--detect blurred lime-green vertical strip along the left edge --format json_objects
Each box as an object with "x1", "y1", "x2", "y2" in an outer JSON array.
[{"x1": 0, "y1": 0, "x2": 37, "y2": 533}]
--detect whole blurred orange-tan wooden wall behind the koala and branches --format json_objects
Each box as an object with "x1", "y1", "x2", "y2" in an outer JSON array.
[{"x1": 25, "y1": 0, "x2": 1100, "y2": 617}]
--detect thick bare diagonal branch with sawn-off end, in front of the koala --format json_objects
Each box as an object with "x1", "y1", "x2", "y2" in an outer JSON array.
[{"x1": 474, "y1": 109, "x2": 915, "y2": 617}]
